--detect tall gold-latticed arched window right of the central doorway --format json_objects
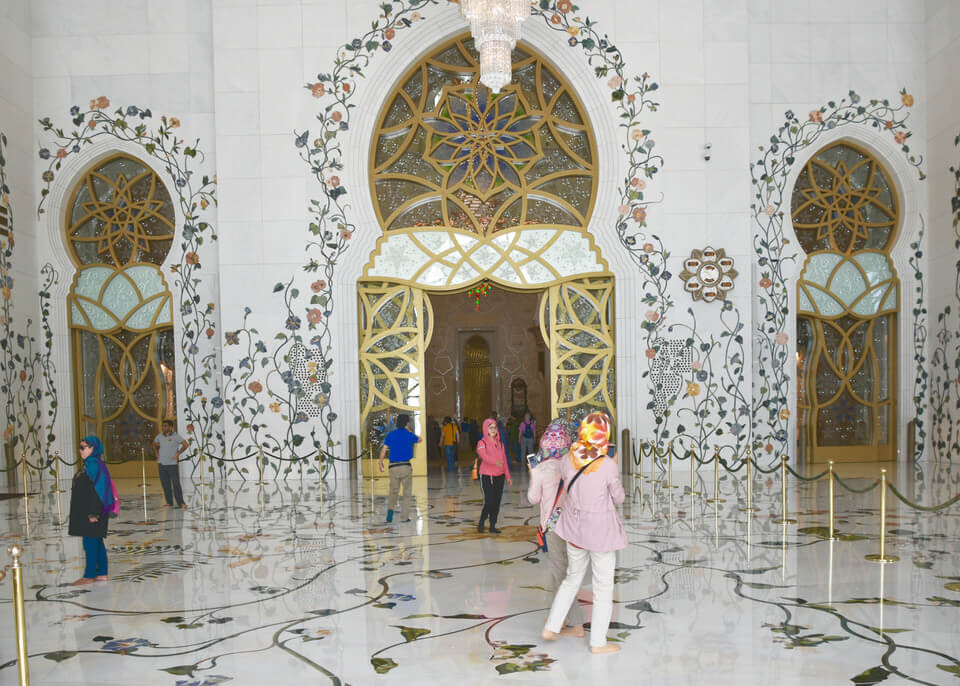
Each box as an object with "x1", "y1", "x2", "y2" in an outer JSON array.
[{"x1": 791, "y1": 141, "x2": 900, "y2": 461}]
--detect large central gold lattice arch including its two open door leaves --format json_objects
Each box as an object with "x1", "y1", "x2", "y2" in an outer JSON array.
[{"x1": 357, "y1": 34, "x2": 616, "y2": 476}]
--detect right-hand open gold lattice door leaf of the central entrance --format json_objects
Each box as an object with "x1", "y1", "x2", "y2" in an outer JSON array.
[{"x1": 540, "y1": 275, "x2": 617, "y2": 425}]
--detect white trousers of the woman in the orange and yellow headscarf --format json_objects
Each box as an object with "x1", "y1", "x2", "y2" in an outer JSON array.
[{"x1": 546, "y1": 543, "x2": 617, "y2": 648}]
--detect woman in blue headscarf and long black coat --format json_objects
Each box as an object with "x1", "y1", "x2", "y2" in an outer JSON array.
[{"x1": 68, "y1": 436, "x2": 117, "y2": 586}]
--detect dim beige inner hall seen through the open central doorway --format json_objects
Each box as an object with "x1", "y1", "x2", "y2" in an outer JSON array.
[{"x1": 424, "y1": 285, "x2": 550, "y2": 473}]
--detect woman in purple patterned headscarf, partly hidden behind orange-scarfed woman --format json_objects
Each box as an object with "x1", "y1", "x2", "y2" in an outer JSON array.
[{"x1": 524, "y1": 419, "x2": 586, "y2": 637}]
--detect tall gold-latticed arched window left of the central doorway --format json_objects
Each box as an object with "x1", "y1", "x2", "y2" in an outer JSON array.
[{"x1": 65, "y1": 154, "x2": 176, "y2": 459}]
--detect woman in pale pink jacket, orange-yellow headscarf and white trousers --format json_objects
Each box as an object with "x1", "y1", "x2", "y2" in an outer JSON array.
[{"x1": 541, "y1": 412, "x2": 627, "y2": 653}]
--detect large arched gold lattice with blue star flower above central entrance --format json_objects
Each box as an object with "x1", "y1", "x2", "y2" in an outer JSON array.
[{"x1": 370, "y1": 35, "x2": 597, "y2": 235}]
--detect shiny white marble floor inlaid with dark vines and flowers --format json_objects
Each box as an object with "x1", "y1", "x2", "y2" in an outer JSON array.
[{"x1": 0, "y1": 464, "x2": 960, "y2": 686}]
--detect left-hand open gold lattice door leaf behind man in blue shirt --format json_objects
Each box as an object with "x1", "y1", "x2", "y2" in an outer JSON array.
[{"x1": 357, "y1": 282, "x2": 433, "y2": 476}]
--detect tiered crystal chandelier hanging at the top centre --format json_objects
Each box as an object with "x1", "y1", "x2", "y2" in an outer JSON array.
[{"x1": 460, "y1": 0, "x2": 530, "y2": 93}]
